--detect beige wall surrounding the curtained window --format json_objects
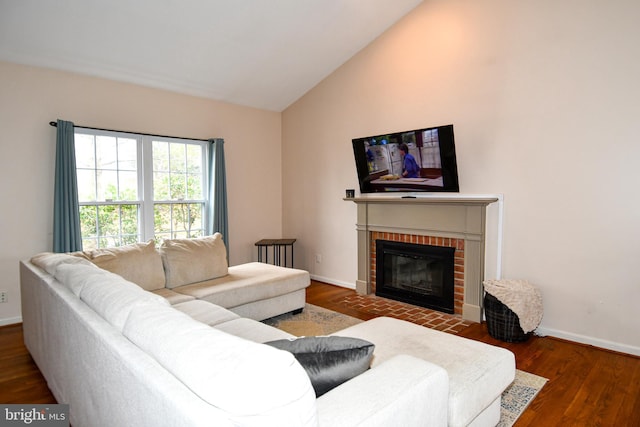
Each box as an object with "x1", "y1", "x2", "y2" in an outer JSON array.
[{"x1": 0, "y1": 62, "x2": 282, "y2": 324}]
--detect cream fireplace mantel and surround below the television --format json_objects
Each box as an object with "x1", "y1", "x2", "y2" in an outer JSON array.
[{"x1": 344, "y1": 193, "x2": 501, "y2": 322}]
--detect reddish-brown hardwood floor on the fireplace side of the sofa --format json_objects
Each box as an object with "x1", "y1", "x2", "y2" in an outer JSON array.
[{"x1": 307, "y1": 282, "x2": 640, "y2": 427}]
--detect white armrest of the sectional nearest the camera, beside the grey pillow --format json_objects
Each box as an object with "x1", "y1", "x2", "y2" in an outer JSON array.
[{"x1": 316, "y1": 355, "x2": 449, "y2": 427}]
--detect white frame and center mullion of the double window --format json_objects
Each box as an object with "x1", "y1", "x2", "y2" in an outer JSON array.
[{"x1": 75, "y1": 127, "x2": 210, "y2": 249}]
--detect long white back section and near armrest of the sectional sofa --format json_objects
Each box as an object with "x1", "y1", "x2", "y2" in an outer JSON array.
[{"x1": 20, "y1": 254, "x2": 448, "y2": 427}]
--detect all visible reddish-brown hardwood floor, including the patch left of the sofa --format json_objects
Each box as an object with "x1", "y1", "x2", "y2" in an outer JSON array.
[{"x1": 0, "y1": 282, "x2": 640, "y2": 427}]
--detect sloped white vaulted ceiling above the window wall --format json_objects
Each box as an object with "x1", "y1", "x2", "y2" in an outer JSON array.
[{"x1": 0, "y1": 0, "x2": 421, "y2": 111}]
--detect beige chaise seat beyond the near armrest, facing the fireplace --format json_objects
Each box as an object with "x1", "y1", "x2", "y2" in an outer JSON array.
[{"x1": 332, "y1": 317, "x2": 516, "y2": 427}]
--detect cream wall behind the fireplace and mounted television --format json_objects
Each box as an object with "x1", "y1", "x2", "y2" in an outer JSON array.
[{"x1": 282, "y1": 0, "x2": 640, "y2": 354}]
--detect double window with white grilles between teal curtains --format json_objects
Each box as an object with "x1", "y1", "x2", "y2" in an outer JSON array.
[{"x1": 75, "y1": 128, "x2": 208, "y2": 250}]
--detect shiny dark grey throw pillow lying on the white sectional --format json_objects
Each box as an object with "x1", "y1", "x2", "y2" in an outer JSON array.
[{"x1": 265, "y1": 336, "x2": 374, "y2": 397}]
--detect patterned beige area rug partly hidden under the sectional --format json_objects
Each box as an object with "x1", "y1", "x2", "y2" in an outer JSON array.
[{"x1": 263, "y1": 304, "x2": 547, "y2": 427}]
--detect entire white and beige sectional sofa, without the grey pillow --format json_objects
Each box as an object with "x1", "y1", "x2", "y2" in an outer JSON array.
[{"x1": 20, "y1": 236, "x2": 515, "y2": 427}]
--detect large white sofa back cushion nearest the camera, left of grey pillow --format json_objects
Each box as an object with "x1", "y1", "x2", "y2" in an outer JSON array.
[{"x1": 123, "y1": 306, "x2": 316, "y2": 426}]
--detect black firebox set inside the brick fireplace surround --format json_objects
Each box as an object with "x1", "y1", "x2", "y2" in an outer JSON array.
[{"x1": 376, "y1": 240, "x2": 455, "y2": 313}]
